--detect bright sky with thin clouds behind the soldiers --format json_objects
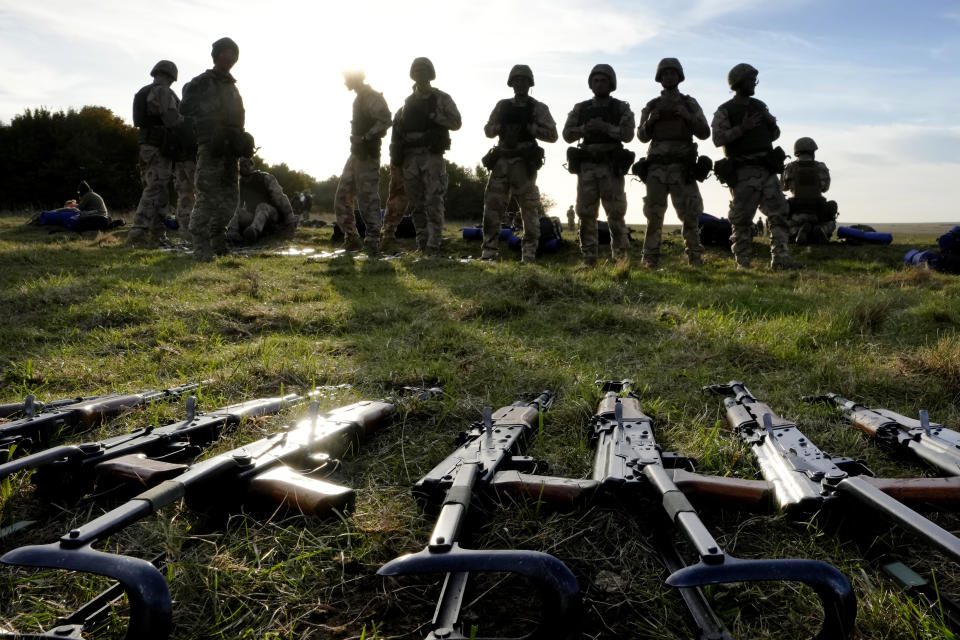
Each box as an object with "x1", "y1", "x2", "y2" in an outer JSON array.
[{"x1": 0, "y1": 0, "x2": 960, "y2": 223}]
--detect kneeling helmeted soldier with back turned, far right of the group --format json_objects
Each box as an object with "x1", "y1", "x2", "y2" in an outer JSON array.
[{"x1": 783, "y1": 138, "x2": 837, "y2": 244}]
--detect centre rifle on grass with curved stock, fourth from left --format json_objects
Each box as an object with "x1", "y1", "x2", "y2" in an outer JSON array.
[{"x1": 377, "y1": 391, "x2": 580, "y2": 640}]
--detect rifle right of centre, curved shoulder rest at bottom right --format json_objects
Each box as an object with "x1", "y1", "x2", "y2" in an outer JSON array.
[{"x1": 496, "y1": 380, "x2": 857, "y2": 640}]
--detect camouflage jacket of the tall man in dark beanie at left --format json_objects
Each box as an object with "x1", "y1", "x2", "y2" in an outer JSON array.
[{"x1": 180, "y1": 69, "x2": 246, "y2": 144}]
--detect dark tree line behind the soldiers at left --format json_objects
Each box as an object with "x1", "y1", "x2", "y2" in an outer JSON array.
[{"x1": 0, "y1": 106, "x2": 489, "y2": 216}]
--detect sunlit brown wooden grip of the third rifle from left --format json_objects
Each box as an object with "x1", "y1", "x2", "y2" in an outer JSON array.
[{"x1": 247, "y1": 466, "x2": 356, "y2": 516}]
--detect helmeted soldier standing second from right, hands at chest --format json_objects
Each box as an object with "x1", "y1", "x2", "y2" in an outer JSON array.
[{"x1": 637, "y1": 58, "x2": 710, "y2": 269}]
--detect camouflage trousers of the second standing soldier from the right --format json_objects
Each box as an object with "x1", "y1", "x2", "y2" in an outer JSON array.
[{"x1": 643, "y1": 164, "x2": 703, "y2": 264}]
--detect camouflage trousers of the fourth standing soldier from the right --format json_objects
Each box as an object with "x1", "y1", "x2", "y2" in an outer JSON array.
[{"x1": 481, "y1": 157, "x2": 540, "y2": 262}]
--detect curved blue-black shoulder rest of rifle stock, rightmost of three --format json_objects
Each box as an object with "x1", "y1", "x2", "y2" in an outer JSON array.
[{"x1": 667, "y1": 555, "x2": 857, "y2": 640}]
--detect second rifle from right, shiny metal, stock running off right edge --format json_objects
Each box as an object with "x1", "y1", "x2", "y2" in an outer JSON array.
[{"x1": 704, "y1": 381, "x2": 960, "y2": 560}]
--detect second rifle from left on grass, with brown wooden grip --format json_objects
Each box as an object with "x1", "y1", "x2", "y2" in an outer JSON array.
[{"x1": 0, "y1": 390, "x2": 306, "y2": 501}]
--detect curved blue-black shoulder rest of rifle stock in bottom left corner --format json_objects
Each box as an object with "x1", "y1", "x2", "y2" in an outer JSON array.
[{"x1": 0, "y1": 542, "x2": 173, "y2": 640}]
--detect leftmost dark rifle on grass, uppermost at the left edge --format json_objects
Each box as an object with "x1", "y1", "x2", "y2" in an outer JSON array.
[{"x1": 0, "y1": 382, "x2": 200, "y2": 457}]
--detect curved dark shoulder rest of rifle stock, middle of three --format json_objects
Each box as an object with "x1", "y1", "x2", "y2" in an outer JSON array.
[{"x1": 377, "y1": 543, "x2": 580, "y2": 639}]
